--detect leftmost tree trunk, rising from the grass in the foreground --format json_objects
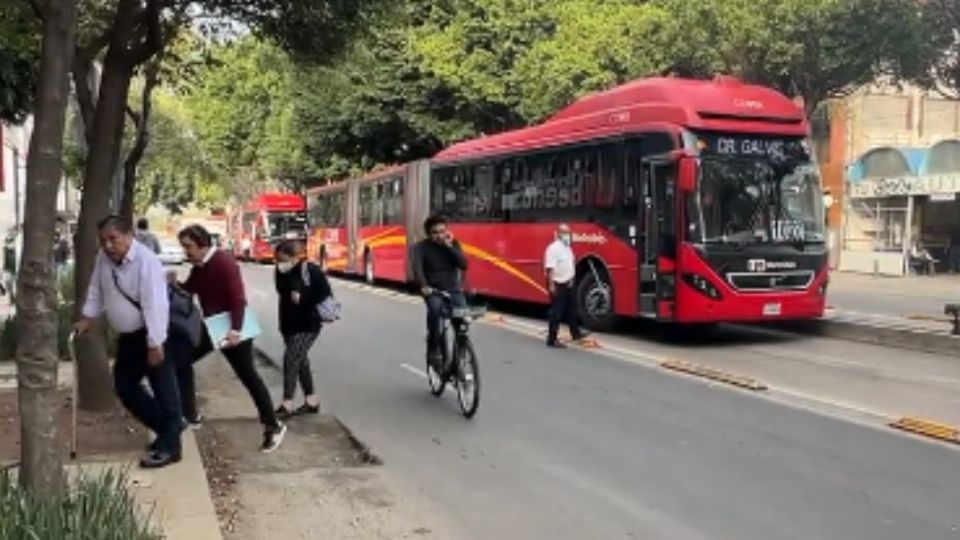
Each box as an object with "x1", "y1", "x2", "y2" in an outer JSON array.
[{"x1": 17, "y1": 0, "x2": 77, "y2": 497}]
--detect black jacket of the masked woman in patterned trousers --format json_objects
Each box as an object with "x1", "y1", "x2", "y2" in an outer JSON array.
[{"x1": 274, "y1": 261, "x2": 333, "y2": 335}]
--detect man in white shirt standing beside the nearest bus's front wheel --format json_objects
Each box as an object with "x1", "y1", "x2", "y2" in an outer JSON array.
[{"x1": 544, "y1": 224, "x2": 586, "y2": 349}]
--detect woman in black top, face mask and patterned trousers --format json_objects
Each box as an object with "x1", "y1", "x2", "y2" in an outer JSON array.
[{"x1": 274, "y1": 240, "x2": 332, "y2": 418}]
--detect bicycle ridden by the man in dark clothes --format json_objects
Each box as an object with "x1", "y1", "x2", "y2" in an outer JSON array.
[{"x1": 427, "y1": 291, "x2": 486, "y2": 418}]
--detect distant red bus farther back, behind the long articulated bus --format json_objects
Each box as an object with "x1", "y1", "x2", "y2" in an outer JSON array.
[{"x1": 229, "y1": 193, "x2": 307, "y2": 262}]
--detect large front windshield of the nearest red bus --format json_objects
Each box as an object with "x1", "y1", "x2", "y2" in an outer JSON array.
[{"x1": 687, "y1": 152, "x2": 825, "y2": 245}]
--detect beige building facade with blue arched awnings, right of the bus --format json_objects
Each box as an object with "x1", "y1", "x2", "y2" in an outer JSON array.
[{"x1": 813, "y1": 85, "x2": 960, "y2": 276}]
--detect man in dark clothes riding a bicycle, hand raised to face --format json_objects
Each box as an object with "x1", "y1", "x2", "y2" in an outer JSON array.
[{"x1": 413, "y1": 216, "x2": 467, "y2": 362}]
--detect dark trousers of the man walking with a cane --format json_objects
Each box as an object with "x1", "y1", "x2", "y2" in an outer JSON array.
[{"x1": 113, "y1": 330, "x2": 183, "y2": 454}]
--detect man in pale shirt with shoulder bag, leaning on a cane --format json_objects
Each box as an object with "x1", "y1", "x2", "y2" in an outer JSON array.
[{"x1": 75, "y1": 216, "x2": 183, "y2": 468}]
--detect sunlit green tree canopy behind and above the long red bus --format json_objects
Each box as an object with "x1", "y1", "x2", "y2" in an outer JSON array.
[{"x1": 172, "y1": 0, "x2": 960, "y2": 194}]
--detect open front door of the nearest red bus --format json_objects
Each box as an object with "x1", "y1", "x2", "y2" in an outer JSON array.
[{"x1": 638, "y1": 158, "x2": 677, "y2": 318}]
